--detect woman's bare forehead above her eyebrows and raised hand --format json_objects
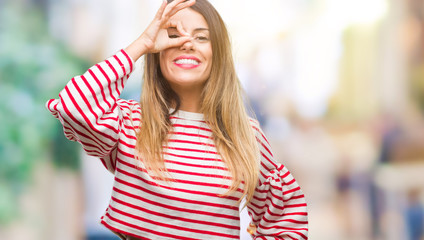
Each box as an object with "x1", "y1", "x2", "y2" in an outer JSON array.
[{"x1": 170, "y1": 8, "x2": 209, "y2": 31}]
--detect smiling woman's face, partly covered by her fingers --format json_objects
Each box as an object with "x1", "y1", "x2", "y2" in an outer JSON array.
[{"x1": 160, "y1": 8, "x2": 212, "y2": 90}]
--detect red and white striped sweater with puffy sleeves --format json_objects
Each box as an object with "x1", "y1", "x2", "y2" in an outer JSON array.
[{"x1": 46, "y1": 50, "x2": 308, "y2": 239}]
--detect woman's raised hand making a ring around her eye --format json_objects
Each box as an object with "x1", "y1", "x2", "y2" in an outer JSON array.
[{"x1": 125, "y1": 0, "x2": 196, "y2": 61}]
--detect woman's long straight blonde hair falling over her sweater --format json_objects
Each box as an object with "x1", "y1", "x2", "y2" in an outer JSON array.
[{"x1": 136, "y1": 0, "x2": 259, "y2": 202}]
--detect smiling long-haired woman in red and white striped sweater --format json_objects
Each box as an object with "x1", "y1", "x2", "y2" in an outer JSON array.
[{"x1": 47, "y1": 0, "x2": 308, "y2": 239}]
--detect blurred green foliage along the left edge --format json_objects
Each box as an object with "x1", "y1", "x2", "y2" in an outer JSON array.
[{"x1": 0, "y1": 1, "x2": 90, "y2": 224}]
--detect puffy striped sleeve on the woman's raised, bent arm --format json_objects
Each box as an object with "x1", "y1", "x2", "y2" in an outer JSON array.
[{"x1": 46, "y1": 50, "x2": 134, "y2": 170}]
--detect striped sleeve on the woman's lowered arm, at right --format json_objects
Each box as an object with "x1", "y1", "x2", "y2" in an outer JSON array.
[{"x1": 247, "y1": 121, "x2": 308, "y2": 240}]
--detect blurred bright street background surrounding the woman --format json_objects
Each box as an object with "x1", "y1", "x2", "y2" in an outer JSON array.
[{"x1": 0, "y1": 0, "x2": 424, "y2": 240}]
